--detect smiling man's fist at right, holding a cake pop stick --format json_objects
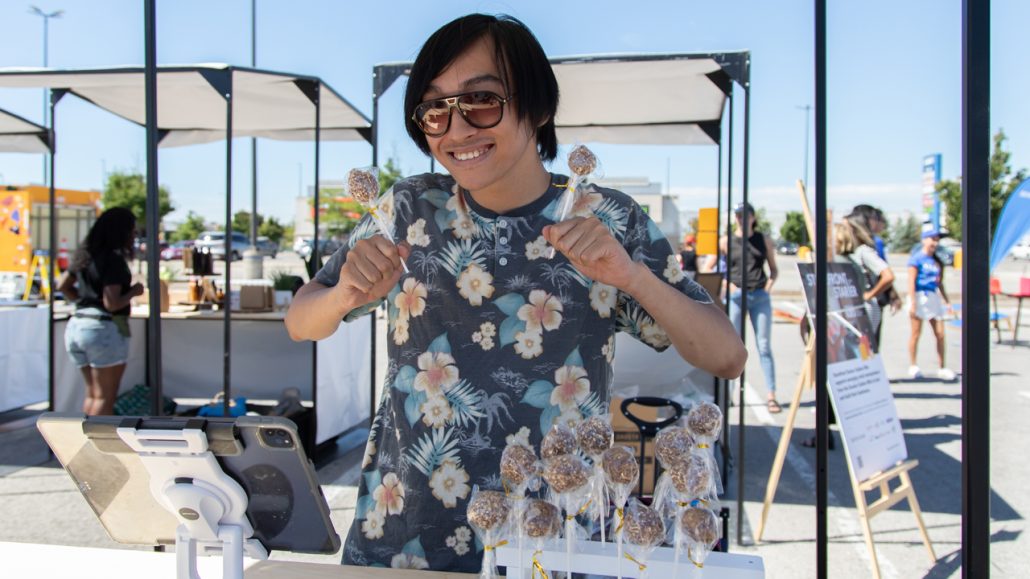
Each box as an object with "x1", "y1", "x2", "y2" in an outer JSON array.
[{"x1": 544, "y1": 217, "x2": 638, "y2": 291}]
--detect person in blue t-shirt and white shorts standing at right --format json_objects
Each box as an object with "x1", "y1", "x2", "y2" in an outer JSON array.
[{"x1": 908, "y1": 229, "x2": 955, "y2": 381}]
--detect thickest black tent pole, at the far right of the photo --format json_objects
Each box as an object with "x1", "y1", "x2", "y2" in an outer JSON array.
[{"x1": 962, "y1": 0, "x2": 991, "y2": 578}]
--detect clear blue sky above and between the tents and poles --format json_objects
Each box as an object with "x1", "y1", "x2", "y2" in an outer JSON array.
[{"x1": 0, "y1": 0, "x2": 1030, "y2": 222}]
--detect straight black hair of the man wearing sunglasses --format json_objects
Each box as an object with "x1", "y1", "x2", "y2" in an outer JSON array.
[{"x1": 404, "y1": 14, "x2": 558, "y2": 161}]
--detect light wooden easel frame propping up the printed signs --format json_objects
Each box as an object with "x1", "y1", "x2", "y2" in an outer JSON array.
[{"x1": 755, "y1": 180, "x2": 937, "y2": 579}]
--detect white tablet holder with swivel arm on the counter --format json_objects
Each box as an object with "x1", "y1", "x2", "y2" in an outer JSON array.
[{"x1": 115, "y1": 427, "x2": 268, "y2": 579}]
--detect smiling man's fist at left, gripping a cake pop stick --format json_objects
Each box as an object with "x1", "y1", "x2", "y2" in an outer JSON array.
[{"x1": 333, "y1": 235, "x2": 411, "y2": 306}]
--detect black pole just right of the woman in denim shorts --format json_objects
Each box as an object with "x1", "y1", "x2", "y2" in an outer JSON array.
[{"x1": 143, "y1": 0, "x2": 163, "y2": 416}]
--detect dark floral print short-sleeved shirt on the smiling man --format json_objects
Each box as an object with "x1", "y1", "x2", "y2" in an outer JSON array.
[{"x1": 315, "y1": 174, "x2": 712, "y2": 573}]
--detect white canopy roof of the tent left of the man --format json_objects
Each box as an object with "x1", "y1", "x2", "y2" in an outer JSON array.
[{"x1": 0, "y1": 64, "x2": 372, "y2": 146}]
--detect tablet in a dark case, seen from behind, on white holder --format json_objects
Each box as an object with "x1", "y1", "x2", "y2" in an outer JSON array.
[{"x1": 37, "y1": 412, "x2": 340, "y2": 553}]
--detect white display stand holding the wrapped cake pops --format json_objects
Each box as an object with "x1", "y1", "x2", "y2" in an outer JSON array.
[{"x1": 496, "y1": 540, "x2": 765, "y2": 579}]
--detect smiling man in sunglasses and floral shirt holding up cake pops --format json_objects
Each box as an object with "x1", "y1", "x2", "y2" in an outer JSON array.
[{"x1": 286, "y1": 14, "x2": 747, "y2": 572}]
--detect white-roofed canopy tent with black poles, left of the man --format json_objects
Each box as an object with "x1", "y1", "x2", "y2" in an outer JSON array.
[{"x1": 0, "y1": 64, "x2": 372, "y2": 451}]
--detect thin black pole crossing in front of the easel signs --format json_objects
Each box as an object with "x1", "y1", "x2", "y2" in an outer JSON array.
[{"x1": 812, "y1": 0, "x2": 829, "y2": 579}]
